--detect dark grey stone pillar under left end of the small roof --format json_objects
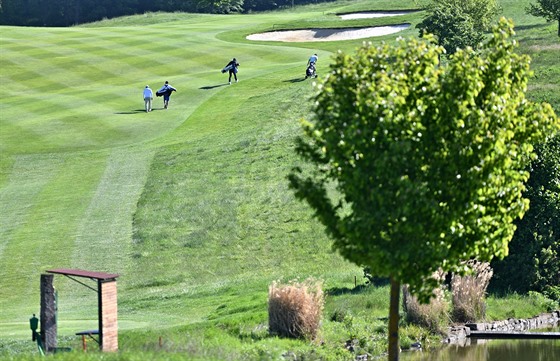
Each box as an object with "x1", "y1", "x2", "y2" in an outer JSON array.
[{"x1": 40, "y1": 274, "x2": 57, "y2": 352}]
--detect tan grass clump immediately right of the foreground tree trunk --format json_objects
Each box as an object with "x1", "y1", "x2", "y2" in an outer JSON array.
[{"x1": 403, "y1": 272, "x2": 449, "y2": 333}]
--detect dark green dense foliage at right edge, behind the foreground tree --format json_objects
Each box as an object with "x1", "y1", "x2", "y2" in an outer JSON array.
[{"x1": 490, "y1": 134, "x2": 560, "y2": 293}]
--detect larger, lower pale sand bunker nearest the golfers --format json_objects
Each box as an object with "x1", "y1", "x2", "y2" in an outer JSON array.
[{"x1": 247, "y1": 24, "x2": 410, "y2": 42}]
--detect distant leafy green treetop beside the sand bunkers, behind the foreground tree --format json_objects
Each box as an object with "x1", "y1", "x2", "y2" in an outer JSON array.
[{"x1": 416, "y1": 0, "x2": 500, "y2": 54}]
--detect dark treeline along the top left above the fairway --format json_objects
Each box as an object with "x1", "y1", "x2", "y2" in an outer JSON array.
[{"x1": 0, "y1": 0, "x2": 329, "y2": 26}]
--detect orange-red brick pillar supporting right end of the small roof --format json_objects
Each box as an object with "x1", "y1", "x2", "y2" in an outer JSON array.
[{"x1": 98, "y1": 280, "x2": 119, "y2": 351}]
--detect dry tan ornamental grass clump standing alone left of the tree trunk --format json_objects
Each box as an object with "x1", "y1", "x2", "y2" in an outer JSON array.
[{"x1": 268, "y1": 279, "x2": 324, "y2": 339}]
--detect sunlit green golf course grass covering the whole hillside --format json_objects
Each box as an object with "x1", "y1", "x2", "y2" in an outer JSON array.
[{"x1": 0, "y1": 0, "x2": 560, "y2": 360}]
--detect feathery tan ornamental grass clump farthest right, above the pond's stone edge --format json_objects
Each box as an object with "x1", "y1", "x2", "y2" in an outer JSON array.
[{"x1": 451, "y1": 260, "x2": 493, "y2": 322}]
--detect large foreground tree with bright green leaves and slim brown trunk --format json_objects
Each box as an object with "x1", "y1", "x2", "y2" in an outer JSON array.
[{"x1": 289, "y1": 20, "x2": 560, "y2": 360}]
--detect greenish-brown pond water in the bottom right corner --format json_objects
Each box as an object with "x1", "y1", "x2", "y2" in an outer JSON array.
[{"x1": 400, "y1": 340, "x2": 560, "y2": 361}]
